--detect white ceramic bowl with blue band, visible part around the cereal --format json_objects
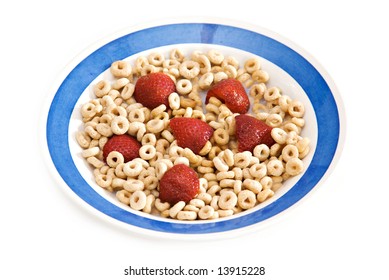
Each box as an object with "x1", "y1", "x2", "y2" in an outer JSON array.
[{"x1": 45, "y1": 19, "x2": 345, "y2": 236}]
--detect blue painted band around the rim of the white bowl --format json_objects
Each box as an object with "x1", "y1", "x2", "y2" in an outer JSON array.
[{"x1": 46, "y1": 23, "x2": 340, "y2": 234}]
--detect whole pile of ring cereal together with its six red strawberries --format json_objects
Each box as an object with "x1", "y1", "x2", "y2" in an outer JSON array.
[{"x1": 76, "y1": 48, "x2": 310, "y2": 220}]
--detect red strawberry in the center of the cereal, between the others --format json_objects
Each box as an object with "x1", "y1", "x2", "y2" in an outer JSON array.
[{"x1": 170, "y1": 117, "x2": 213, "y2": 154}]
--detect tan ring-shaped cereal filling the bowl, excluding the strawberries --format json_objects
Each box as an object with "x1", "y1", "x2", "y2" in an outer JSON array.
[{"x1": 75, "y1": 48, "x2": 310, "y2": 221}]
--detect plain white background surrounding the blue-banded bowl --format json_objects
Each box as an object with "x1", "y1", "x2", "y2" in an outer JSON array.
[{"x1": 0, "y1": 0, "x2": 389, "y2": 280}]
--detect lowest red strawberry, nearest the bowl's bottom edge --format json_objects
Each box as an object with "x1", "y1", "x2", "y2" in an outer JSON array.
[{"x1": 159, "y1": 164, "x2": 200, "y2": 205}]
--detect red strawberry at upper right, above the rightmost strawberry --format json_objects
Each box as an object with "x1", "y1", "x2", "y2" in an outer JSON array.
[{"x1": 205, "y1": 78, "x2": 250, "y2": 114}]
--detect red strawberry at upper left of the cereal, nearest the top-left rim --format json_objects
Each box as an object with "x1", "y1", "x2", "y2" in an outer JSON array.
[{"x1": 134, "y1": 72, "x2": 176, "y2": 109}]
